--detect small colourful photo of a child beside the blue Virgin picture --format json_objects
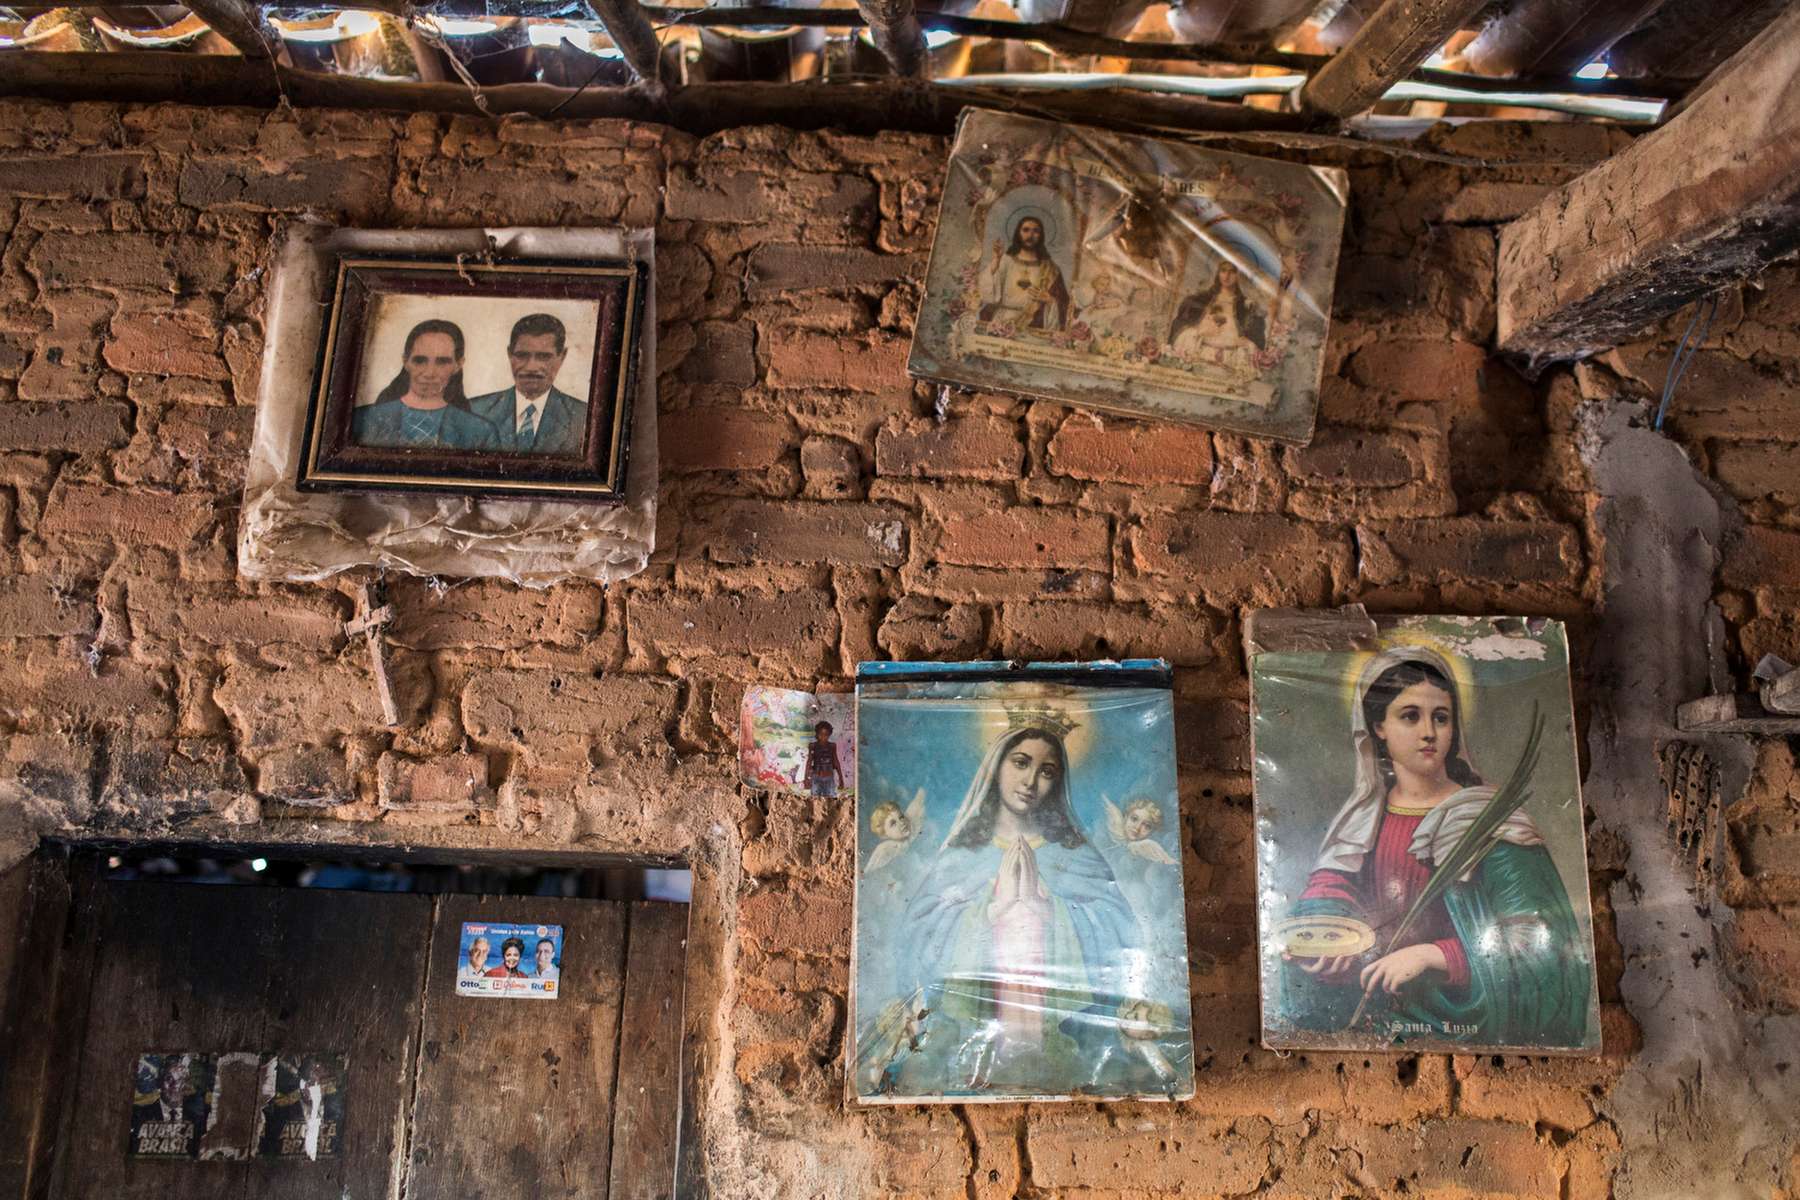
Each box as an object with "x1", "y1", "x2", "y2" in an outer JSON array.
[{"x1": 738, "y1": 687, "x2": 857, "y2": 799}]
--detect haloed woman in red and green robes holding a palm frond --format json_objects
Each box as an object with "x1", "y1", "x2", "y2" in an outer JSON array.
[{"x1": 1282, "y1": 646, "x2": 1593, "y2": 1045}]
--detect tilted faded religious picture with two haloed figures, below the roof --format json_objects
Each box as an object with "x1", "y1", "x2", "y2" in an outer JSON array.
[{"x1": 907, "y1": 110, "x2": 1348, "y2": 443}]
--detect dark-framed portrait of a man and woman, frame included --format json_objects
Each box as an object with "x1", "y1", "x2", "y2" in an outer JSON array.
[{"x1": 297, "y1": 254, "x2": 648, "y2": 504}]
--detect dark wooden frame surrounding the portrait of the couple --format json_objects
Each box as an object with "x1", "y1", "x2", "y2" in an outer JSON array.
[{"x1": 297, "y1": 254, "x2": 650, "y2": 504}]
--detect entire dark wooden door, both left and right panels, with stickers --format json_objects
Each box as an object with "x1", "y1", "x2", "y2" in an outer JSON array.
[{"x1": 0, "y1": 876, "x2": 688, "y2": 1200}]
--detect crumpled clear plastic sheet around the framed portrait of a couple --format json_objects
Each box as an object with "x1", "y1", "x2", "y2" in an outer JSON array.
[{"x1": 238, "y1": 225, "x2": 657, "y2": 587}]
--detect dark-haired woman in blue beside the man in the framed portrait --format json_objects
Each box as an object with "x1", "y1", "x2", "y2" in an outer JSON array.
[{"x1": 351, "y1": 320, "x2": 499, "y2": 450}]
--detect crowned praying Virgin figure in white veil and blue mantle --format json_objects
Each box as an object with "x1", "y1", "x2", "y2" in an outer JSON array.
[{"x1": 905, "y1": 707, "x2": 1139, "y2": 1090}]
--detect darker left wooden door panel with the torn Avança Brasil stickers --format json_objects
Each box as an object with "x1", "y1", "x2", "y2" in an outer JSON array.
[{"x1": 58, "y1": 882, "x2": 432, "y2": 1200}]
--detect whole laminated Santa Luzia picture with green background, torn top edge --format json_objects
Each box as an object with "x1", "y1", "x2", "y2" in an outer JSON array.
[{"x1": 1246, "y1": 608, "x2": 1600, "y2": 1054}]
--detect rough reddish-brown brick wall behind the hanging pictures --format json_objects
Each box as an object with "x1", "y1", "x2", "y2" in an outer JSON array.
[{"x1": 0, "y1": 103, "x2": 1800, "y2": 1200}]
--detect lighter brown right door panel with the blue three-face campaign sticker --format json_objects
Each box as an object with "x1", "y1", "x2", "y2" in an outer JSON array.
[{"x1": 407, "y1": 896, "x2": 688, "y2": 1200}]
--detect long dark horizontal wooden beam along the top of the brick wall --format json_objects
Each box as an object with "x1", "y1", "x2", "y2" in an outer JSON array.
[{"x1": 0, "y1": 50, "x2": 1305, "y2": 135}]
